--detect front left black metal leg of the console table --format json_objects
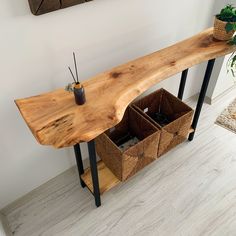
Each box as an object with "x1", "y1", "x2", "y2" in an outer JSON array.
[{"x1": 88, "y1": 140, "x2": 101, "y2": 207}]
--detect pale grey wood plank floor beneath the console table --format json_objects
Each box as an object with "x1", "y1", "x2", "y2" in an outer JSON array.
[{"x1": 3, "y1": 91, "x2": 236, "y2": 236}]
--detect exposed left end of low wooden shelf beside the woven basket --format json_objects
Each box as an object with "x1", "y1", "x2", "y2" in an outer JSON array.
[{"x1": 81, "y1": 161, "x2": 121, "y2": 194}]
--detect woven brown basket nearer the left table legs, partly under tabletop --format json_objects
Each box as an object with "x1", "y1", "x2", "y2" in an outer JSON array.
[{"x1": 96, "y1": 107, "x2": 161, "y2": 181}]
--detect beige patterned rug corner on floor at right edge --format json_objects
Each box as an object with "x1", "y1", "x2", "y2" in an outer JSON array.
[{"x1": 216, "y1": 99, "x2": 236, "y2": 133}]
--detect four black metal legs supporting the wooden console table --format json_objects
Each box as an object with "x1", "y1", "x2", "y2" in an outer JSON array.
[{"x1": 74, "y1": 59, "x2": 215, "y2": 207}]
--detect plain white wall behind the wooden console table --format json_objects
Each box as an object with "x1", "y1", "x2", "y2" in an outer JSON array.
[{"x1": 0, "y1": 0, "x2": 225, "y2": 208}]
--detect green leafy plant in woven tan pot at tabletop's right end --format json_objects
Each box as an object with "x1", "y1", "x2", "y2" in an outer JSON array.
[{"x1": 213, "y1": 5, "x2": 236, "y2": 41}]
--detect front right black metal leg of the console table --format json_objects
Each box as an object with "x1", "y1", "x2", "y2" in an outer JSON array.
[{"x1": 188, "y1": 59, "x2": 215, "y2": 141}]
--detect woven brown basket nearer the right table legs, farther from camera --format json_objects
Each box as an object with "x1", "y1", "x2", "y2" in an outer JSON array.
[{"x1": 132, "y1": 89, "x2": 193, "y2": 157}]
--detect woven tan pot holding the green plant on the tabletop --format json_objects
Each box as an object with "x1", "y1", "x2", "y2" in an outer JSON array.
[{"x1": 213, "y1": 18, "x2": 235, "y2": 41}]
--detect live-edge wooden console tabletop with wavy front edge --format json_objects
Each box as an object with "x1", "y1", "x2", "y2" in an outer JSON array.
[{"x1": 15, "y1": 28, "x2": 236, "y2": 148}]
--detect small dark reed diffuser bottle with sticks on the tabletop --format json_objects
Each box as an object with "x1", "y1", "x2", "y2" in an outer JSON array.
[{"x1": 65, "y1": 52, "x2": 86, "y2": 105}]
